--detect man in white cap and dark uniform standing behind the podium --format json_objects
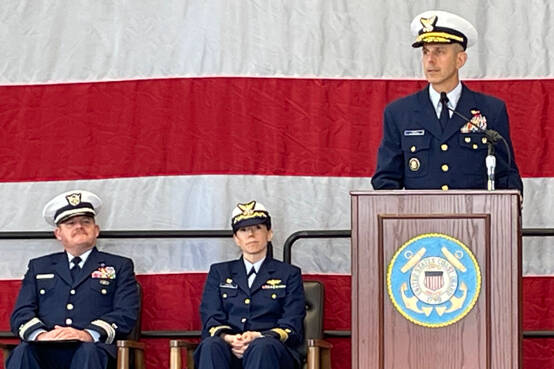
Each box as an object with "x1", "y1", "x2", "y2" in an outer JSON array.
[{"x1": 371, "y1": 10, "x2": 523, "y2": 193}]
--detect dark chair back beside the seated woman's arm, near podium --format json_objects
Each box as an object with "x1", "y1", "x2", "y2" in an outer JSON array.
[{"x1": 300, "y1": 281, "x2": 325, "y2": 357}]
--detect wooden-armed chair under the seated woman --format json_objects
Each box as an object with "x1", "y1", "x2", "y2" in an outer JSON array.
[{"x1": 169, "y1": 281, "x2": 332, "y2": 369}]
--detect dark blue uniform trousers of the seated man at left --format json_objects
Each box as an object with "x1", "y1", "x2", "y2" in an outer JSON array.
[{"x1": 6, "y1": 342, "x2": 115, "y2": 369}]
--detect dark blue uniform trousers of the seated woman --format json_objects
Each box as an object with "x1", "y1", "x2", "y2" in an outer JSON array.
[{"x1": 194, "y1": 336, "x2": 297, "y2": 369}]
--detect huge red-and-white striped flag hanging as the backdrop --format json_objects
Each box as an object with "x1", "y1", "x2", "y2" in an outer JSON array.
[{"x1": 0, "y1": 0, "x2": 554, "y2": 369}]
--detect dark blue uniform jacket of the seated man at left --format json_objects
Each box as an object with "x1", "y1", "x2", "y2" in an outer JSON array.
[{"x1": 10, "y1": 247, "x2": 139, "y2": 356}]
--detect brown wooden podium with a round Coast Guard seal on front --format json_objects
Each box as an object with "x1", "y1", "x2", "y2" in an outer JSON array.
[{"x1": 351, "y1": 190, "x2": 521, "y2": 369}]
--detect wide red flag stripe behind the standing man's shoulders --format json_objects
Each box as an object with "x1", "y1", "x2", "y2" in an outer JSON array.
[{"x1": 0, "y1": 78, "x2": 554, "y2": 182}]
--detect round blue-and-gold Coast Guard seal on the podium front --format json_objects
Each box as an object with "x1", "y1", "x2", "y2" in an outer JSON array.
[{"x1": 387, "y1": 233, "x2": 481, "y2": 328}]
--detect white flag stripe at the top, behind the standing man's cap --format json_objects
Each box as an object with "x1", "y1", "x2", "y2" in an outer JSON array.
[{"x1": 0, "y1": 0, "x2": 554, "y2": 84}]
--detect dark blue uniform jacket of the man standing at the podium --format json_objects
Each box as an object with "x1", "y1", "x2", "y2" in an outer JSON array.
[{"x1": 371, "y1": 85, "x2": 523, "y2": 193}]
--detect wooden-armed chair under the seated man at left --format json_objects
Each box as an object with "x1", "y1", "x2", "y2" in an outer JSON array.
[{"x1": 0, "y1": 282, "x2": 145, "y2": 369}]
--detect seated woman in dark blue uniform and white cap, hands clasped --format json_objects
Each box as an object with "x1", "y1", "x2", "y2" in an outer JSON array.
[{"x1": 194, "y1": 201, "x2": 306, "y2": 369}]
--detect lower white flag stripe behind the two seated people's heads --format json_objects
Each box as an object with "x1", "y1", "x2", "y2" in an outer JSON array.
[{"x1": 0, "y1": 175, "x2": 554, "y2": 279}]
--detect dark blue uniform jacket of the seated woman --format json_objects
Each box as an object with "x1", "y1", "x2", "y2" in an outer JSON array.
[{"x1": 200, "y1": 257, "x2": 306, "y2": 361}]
